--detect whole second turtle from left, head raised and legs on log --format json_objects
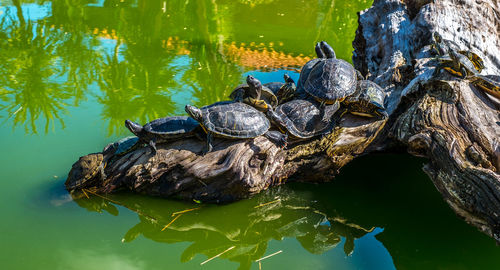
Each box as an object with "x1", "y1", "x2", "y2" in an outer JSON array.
[{"x1": 185, "y1": 101, "x2": 287, "y2": 153}]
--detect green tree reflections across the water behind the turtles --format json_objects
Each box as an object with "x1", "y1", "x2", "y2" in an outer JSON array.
[{"x1": 0, "y1": 0, "x2": 369, "y2": 135}]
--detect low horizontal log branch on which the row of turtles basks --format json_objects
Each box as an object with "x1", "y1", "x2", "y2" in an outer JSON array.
[{"x1": 66, "y1": 114, "x2": 386, "y2": 202}]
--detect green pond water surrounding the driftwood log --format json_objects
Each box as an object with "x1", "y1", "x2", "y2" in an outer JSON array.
[{"x1": 0, "y1": 0, "x2": 500, "y2": 269}]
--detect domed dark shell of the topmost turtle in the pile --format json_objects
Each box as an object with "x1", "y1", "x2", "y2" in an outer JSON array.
[{"x1": 304, "y1": 58, "x2": 356, "y2": 104}]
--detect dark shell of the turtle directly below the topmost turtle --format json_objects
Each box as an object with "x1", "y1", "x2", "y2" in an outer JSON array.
[{"x1": 276, "y1": 99, "x2": 335, "y2": 139}]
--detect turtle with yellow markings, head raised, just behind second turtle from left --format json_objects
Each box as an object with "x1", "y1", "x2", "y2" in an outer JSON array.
[{"x1": 229, "y1": 75, "x2": 278, "y2": 111}]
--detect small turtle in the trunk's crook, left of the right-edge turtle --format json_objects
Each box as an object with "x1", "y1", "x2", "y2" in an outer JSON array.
[{"x1": 436, "y1": 48, "x2": 478, "y2": 79}]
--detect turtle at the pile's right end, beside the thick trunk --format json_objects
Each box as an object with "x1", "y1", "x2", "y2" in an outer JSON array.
[{"x1": 343, "y1": 80, "x2": 388, "y2": 119}]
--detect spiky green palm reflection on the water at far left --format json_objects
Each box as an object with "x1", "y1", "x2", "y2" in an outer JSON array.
[{"x1": 0, "y1": 5, "x2": 72, "y2": 133}]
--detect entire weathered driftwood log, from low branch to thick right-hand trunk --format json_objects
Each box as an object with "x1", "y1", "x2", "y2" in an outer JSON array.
[{"x1": 66, "y1": 0, "x2": 500, "y2": 242}]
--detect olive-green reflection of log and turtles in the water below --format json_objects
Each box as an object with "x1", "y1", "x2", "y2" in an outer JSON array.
[{"x1": 75, "y1": 188, "x2": 374, "y2": 269}]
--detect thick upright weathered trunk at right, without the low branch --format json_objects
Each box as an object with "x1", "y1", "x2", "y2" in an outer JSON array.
[{"x1": 354, "y1": 0, "x2": 500, "y2": 241}]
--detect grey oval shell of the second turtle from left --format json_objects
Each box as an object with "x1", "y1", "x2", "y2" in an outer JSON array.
[{"x1": 201, "y1": 102, "x2": 271, "y2": 139}]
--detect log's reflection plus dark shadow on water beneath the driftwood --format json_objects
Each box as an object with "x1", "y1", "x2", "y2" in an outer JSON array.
[{"x1": 46, "y1": 155, "x2": 500, "y2": 269}]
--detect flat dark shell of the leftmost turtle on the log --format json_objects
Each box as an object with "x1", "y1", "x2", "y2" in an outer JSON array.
[{"x1": 144, "y1": 116, "x2": 200, "y2": 139}]
